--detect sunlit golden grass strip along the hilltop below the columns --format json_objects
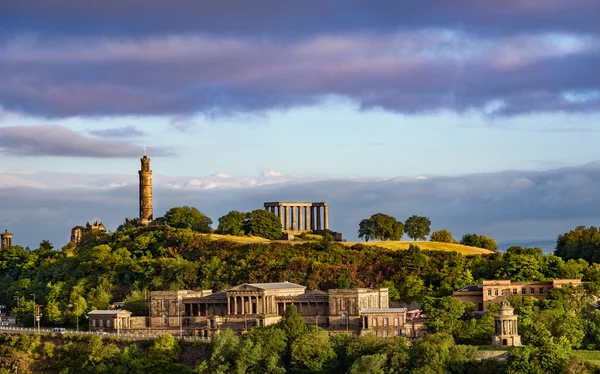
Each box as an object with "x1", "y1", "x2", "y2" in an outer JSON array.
[{"x1": 205, "y1": 234, "x2": 492, "y2": 255}]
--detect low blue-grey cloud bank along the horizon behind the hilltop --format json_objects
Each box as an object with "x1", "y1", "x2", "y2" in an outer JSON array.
[{"x1": 0, "y1": 163, "x2": 600, "y2": 250}]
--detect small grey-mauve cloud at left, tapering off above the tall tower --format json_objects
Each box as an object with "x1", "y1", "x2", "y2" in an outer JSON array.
[{"x1": 0, "y1": 125, "x2": 167, "y2": 158}]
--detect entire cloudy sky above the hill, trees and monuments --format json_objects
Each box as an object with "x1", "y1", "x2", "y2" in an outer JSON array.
[{"x1": 0, "y1": 0, "x2": 600, "y2": 248}]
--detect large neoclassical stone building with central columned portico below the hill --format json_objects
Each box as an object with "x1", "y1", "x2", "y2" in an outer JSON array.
[{"x1": 150, "y1": 282, "x2": 414, "y2": 337}]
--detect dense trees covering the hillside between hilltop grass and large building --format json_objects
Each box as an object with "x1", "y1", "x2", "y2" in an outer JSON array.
[{"x1": 0, "y1": 226, "x2": 600, "y2": 325}]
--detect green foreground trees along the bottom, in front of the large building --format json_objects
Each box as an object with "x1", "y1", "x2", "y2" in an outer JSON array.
[{"x1": 0, "y1": 307, "x2": 600, "y2": 374}]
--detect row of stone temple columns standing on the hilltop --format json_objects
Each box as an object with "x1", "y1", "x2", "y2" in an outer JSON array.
[{"x1": 265, "y1": 203, "x2": 329, "y2": 231}]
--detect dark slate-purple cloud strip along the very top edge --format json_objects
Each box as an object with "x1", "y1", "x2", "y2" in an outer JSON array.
[{"x1": 0, "y1": 0, "x2": 600, "y2": 38}]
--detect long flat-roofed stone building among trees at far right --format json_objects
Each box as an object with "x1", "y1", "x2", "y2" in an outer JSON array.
[{"x1": 452, "y1": 279, "x2": 581, "y2": 312}]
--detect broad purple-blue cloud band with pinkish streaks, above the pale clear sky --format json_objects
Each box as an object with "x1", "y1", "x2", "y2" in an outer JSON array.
[{"x1": 0, "y1": 27, "x2": 600, "y2": 118}]
